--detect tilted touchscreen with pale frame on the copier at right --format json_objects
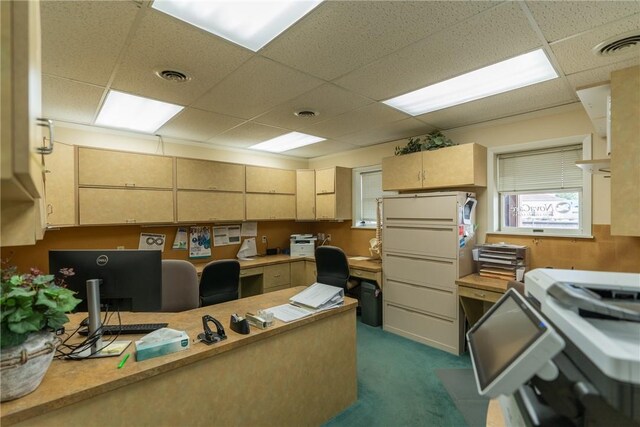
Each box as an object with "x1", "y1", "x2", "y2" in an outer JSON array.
[{"x1": 467, "y1": 289, "x2": 564, "y2": 397}]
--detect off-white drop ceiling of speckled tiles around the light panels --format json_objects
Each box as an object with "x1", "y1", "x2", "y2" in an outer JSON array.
[{"x1": 41, "y1": 1, "x2": 640, "y2": 158}]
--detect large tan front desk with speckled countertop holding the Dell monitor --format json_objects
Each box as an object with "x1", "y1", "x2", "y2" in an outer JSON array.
[{"x1": 0, "y1": 287, "x2": 357, "y2": 427}]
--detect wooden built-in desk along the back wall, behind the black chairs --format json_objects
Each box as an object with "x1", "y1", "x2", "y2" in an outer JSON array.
[{"x1": 193, "y1": 255, "x2": 383, "y2": 298}]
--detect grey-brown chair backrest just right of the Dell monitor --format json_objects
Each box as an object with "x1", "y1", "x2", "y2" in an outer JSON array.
[{"x1": 160, "y1": 259, "x2": 200, "y2": 312}]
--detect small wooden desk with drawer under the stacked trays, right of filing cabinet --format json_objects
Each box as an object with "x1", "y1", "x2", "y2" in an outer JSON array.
[{"x1": 456, "y1": 274, "x2": 508, "y2": 326}]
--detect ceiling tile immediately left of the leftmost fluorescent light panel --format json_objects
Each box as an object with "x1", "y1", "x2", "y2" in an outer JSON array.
[{"x1": 42, "y1": 74, "x2": 105, "y2": 124}]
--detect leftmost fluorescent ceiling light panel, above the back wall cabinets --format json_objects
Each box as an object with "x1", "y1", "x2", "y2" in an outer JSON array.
[{"x1": 96, "y1": 90, "x2": 184, "y2": 133}]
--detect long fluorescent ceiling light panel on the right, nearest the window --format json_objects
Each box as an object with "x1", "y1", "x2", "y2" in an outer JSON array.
[{"x1": 383, "y1": 49, "x2": 558, "y2": 116}]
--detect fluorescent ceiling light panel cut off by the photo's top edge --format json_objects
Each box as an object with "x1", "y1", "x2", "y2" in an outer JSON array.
[{"x1": 152, "y1": 0, "x2": 322, "y2": 52}]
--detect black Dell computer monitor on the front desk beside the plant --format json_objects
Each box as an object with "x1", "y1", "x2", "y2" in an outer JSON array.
[{"x1": 49, "y1": 249, "x2": 162, "y2": 311}]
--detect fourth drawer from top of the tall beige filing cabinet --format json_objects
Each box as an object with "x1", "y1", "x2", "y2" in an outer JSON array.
[{"x1": 384, "y1": 278, "x2": 458, "y2": 319}]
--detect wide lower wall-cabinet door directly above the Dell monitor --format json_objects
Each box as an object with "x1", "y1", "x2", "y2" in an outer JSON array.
[{"x1": 78, "y1": 188, "x2": 173, "y2": 225}]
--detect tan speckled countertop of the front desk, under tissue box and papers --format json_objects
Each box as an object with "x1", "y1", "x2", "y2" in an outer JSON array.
[{"x1": 0, "y1": 286, "x2": 357, "y2": 425}]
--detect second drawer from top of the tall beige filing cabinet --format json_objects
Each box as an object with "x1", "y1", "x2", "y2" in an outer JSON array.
[{"x1": 382, "y1": 224, "x2": 458, "y2": 259}]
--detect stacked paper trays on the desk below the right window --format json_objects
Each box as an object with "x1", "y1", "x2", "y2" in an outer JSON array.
[{"x1": 476, "y1": 244, "x2": 529, "y2": 281}]
